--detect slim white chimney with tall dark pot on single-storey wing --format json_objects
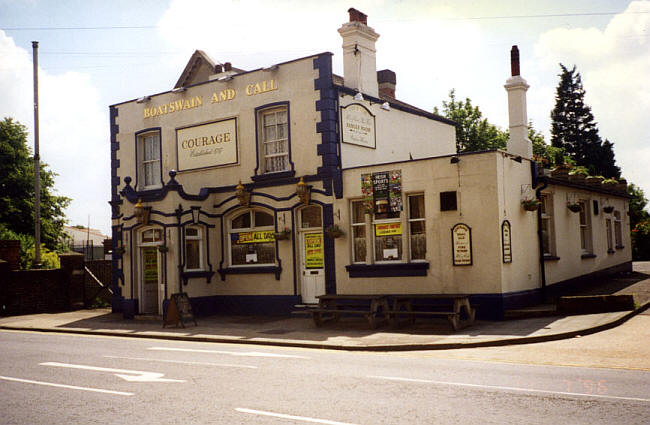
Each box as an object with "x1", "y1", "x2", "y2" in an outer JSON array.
[{"x1": 504, "y1": 46, "x2": 533, "y2": 159}]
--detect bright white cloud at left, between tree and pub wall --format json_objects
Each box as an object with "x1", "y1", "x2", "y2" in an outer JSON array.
[{"x1": 0, "y1": 31, "x2": 110, "y2": 234}]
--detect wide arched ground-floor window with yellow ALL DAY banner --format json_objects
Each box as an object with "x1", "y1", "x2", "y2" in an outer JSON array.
[{"x1": 228, "y1": 209, "x2": 275, "y2": 266}]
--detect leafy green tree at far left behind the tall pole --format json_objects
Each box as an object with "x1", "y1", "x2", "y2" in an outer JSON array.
[{"x1": 0, "y1": 118, "x2": 70, "y2": 249}]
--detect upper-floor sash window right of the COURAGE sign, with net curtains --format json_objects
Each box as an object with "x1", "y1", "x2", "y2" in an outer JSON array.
[{"x1": 259, "y1": 106, "x2": 289, "y2": 173}]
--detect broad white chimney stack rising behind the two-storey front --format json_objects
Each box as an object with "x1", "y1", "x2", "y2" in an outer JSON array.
[{"x1": 338, "y1": 8, "x2": 379, "y2": 97}]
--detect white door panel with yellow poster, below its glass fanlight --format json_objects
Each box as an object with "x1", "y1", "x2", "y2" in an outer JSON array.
[{"x1": 301, "y1": 231, "x2": 325, "y2": 303}]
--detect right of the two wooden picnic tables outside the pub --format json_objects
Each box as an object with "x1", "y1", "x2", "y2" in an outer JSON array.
[{"x1": 389, "y1": 294, "x2": 476, "y2": 331}]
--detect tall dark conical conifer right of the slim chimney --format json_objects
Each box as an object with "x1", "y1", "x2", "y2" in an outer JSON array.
[{"x1": 551, "y1": 64, "x2": 621, "y2": 178}]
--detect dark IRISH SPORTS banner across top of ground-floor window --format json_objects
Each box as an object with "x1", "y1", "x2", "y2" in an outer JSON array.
[{"x1": 361, "y1": 170, "x2": 402, "y2": 214}]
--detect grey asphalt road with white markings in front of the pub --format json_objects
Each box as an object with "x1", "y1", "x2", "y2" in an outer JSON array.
[{"x1": 0, "y1": 331, "x2": 650, "y2": 425}]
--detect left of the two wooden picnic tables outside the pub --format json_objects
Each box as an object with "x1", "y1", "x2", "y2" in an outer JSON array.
[{"x1": 307, "y1": 294, "x2": 389, "y2": 329}]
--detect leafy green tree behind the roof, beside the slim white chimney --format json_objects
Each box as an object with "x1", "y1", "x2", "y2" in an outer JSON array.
[{"x1": 433, "y1": 89, "x2": 508, "y2": 153}]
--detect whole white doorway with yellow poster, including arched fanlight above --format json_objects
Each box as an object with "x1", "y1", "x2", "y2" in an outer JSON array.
[{"x1": 298, "y1": 205, "x2": 325, "y2": 304}]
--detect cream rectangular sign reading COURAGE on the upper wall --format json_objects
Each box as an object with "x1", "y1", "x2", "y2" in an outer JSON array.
[{"x1": 176, "y1": 118, "x2": 238, "y2": 171}]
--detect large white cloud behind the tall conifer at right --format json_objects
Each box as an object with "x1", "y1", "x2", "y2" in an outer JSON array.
[{"x1": 536, "y1": 1, "x2": 650, "y2": 194}]
